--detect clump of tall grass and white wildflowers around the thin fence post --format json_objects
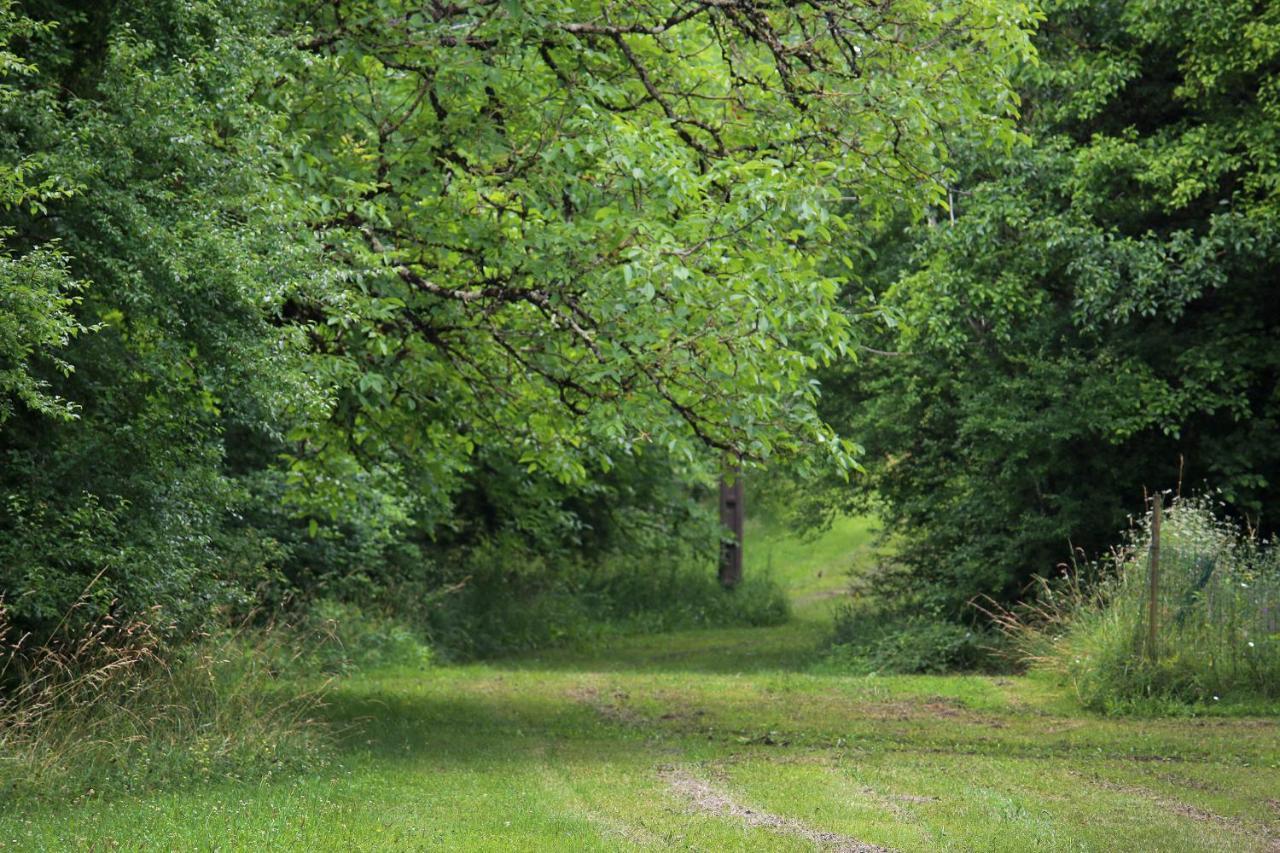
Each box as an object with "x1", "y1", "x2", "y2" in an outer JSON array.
[{"x1": 995, "y1": 498, "x2": 1280, "y2": 711}]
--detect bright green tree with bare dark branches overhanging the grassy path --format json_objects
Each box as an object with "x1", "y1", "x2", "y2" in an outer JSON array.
[{"x1": 282, "y1": 0, "x2": 1029, "y2": 506}]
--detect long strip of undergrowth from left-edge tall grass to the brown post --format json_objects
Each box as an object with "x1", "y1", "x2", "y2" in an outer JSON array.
[{"x1": 0, "y1": 535, "x2": 788, "y2": 802}]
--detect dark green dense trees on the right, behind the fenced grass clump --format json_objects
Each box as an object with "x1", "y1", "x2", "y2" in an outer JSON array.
[{"x1": 828, "y1": 0, "x2": 1280, "y2": 613}]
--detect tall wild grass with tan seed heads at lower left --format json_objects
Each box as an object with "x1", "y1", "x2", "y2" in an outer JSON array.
[{"x1": 0, "y1": 596, "x2": 325, "y2": 803}]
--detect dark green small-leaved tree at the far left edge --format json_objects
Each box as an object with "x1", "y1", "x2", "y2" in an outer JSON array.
[{"x1": 0, "y1": 0, "x2": 320, "y2": 635}]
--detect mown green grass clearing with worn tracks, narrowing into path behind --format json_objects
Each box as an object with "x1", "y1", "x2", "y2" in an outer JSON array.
[{"x1": 0, "y1": 520, "x2": 1280, "y2": 852}]
